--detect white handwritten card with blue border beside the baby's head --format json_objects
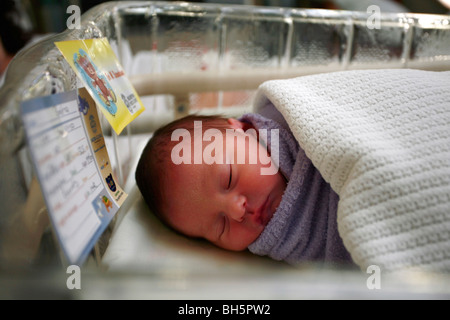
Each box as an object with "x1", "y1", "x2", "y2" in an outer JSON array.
[{"x1": 21, "y1": 88, "x2": 127, "y2": 265}]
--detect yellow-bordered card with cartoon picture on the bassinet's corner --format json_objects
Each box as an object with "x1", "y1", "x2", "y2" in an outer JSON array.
[{"x1": 55, "y1": 38, "x2": 144, "y2": 134}]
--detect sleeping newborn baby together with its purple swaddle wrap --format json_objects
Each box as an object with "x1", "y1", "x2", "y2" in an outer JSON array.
[{"x1": 136, "y1": 114, "x2": 351, "y2": 264}]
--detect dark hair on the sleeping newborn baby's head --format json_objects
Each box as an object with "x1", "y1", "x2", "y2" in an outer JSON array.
[{"x1": 135, "y1": 114, "x2": 231, "y2": 224}]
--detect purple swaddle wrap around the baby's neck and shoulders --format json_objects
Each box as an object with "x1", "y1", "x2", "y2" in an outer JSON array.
[{"x1": 240, "y1": 104, "x2": 352, "y2": 265}]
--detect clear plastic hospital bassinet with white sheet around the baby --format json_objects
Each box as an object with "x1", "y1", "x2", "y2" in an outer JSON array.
[{"x1": 0, "y1": 2, "x2": 450, "y2": 299}]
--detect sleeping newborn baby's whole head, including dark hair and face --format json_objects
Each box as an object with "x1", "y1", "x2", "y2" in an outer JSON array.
[{"x1": 136, "y1": 116, "x2": 286, "y2": 251}]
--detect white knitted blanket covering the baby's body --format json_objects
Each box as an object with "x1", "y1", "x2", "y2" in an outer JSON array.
[{"x1": 255, "y1": 69, "x2": 450, "y2": 272}]
